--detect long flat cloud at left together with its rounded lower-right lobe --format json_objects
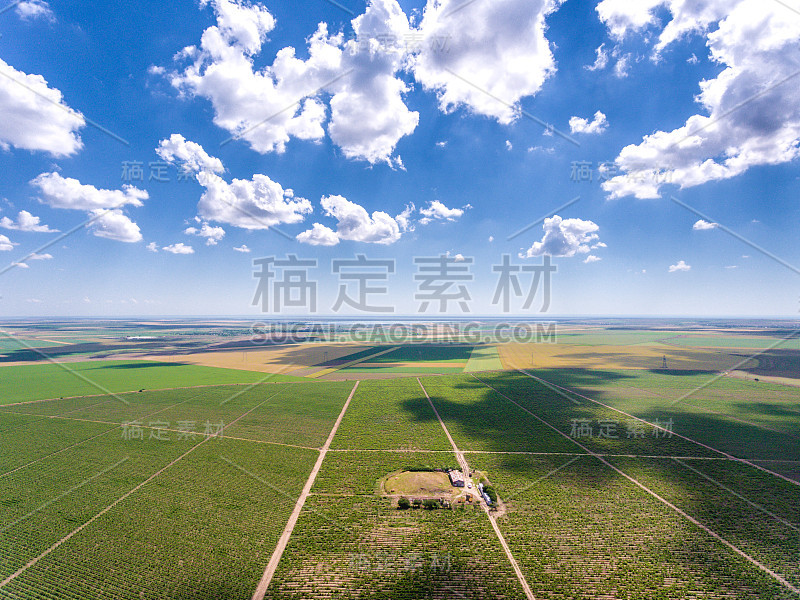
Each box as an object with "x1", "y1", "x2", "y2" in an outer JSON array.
[{"x1": 30, "y1": 172, "x2": 144, "y2": 243}]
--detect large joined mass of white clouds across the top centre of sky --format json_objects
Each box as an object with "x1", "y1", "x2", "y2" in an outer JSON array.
[{"x1": 162, "y1": 0, "x2": 562, "y2": 168}]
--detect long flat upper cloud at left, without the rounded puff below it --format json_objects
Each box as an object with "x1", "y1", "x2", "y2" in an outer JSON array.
[{"x1": 30, "y1": 172, "x2": 149, "y2": 210}]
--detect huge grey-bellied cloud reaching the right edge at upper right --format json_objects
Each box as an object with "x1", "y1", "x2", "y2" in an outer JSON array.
[{"x1": 597, "y1": 0, "x2": 800, "y2": 198}]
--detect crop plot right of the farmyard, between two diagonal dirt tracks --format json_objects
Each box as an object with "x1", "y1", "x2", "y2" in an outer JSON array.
[{"x1": 470, "y1": 455, "x2": 793, "y2": 600}]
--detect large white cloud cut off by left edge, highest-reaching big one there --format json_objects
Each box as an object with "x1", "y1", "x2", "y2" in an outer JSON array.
[{"x1": 0, "y1": 59, "x2": 86, "y2": 157}]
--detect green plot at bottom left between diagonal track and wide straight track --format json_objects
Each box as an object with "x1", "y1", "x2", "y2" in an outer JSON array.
[{"x1": 0, "y1": 439, "x2": 317, "y2": 599}]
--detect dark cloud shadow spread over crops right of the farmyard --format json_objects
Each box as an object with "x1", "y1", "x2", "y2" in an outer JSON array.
[{"x1": 390, "y1": 371, "x2": 800, "y2": 598}]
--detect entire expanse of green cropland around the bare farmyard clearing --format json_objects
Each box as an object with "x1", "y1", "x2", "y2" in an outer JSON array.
[{"x1": 0, "y1": 345, "x2": 800, "y2": 600}]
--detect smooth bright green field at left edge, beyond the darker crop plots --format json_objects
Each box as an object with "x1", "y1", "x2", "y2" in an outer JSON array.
[{"x1": 0, "y1": 360, "x2": 298, "y2": 404}]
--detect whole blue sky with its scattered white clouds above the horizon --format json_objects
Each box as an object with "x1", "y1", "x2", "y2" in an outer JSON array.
[{"x1": 0, "y1": 0, "x2": 800, "y2": 316}]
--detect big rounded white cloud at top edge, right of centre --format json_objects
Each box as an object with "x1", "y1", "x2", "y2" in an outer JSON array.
[{"x1": 412, "y1": 0, "x2": 560, "y2": 124}]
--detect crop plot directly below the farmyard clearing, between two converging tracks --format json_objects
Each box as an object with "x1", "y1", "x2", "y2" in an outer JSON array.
[{"x1": 267, "y1": 496, "x2": 525, "y2": 600}]
